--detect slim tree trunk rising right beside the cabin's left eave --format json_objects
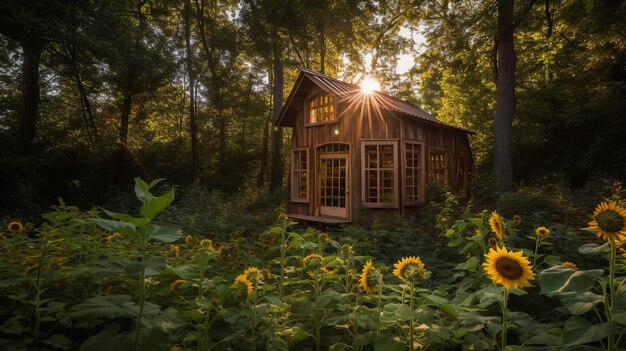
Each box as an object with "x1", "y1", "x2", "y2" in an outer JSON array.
[{"x1": 270, "y1": 50, "x2": 285, "y2": 191}]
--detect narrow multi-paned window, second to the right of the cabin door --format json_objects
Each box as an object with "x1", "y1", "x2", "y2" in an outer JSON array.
[{"x1": 404, "y1": 142, "x2": 424, "y2": 204}]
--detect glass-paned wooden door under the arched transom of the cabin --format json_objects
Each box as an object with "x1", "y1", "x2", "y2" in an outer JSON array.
[{"x1": 319, "y1": 153, "x2": 350, "y2": 218}]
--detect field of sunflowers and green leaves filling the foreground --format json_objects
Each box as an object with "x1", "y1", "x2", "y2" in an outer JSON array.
[{"x1": 0, "y1": 178, "x2": 626, "y2": 350}]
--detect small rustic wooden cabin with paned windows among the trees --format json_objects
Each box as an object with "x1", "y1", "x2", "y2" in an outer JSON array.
[{"x1": 274, "y1": 68, "x2": 473, "y2": 223}]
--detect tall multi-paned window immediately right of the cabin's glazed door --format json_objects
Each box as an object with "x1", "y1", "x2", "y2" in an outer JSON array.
[{"x1": 361, "y1": 142, "x2": 398, "y2": 207}]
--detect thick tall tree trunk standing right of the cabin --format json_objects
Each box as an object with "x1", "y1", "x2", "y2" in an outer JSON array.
[{"x1": 494, "y1": 0, "x2": 515, "y2": 190}]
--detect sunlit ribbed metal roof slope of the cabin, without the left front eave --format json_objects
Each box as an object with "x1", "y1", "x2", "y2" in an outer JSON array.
[{"x1": 280, "y1": 67, "x2": 474, "y2": 134}]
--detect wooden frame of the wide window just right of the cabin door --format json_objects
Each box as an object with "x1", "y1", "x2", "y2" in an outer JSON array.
[{"x1": 360, "y1": 139, "x2": 400, "y2": 208}]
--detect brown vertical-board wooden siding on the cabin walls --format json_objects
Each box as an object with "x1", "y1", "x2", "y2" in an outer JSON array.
[{"x1": 287, "y1": 91, "x2": 473, "y2": 221}]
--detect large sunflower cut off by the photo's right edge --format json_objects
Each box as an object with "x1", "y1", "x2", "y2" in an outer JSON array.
[{"x1": 588, "y1": 201, "x2": 626, "y2": 241}]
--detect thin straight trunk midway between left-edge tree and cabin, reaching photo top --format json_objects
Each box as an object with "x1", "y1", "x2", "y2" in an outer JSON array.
[{"x1": 184, "y1": 0, "x2": 199, "y2": 182}]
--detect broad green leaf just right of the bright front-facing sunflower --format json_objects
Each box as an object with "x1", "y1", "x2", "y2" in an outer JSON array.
[{"x1": 539, "y1": 266, "x2": 604, "y2": 295}]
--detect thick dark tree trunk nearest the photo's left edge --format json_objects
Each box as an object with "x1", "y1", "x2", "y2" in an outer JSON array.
[{"x1": 15, "y1": 38, "x2": 43, "y2": 156}]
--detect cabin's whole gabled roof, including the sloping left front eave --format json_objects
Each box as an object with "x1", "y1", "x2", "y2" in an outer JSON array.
[{"x1": 273, "y1": 67, "x2": 473, "y2": 134}]
